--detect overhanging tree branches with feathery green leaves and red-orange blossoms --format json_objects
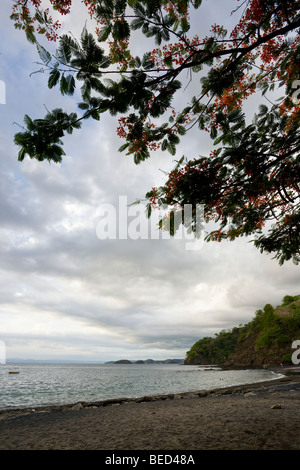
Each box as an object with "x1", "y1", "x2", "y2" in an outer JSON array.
[{"x1": 11, "y1": 0, "x2": 300, "y2": 263}]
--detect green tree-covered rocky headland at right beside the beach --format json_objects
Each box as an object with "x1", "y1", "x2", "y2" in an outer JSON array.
[{"x1": 185, "y1": 295, "x2": 300, "y2": 367}]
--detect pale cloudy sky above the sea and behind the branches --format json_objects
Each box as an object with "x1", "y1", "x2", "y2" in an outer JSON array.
[{"x1": 0, "y1": 0, "x2": 300, "y2": 361}]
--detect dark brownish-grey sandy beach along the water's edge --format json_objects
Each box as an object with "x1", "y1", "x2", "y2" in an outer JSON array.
[{"x1": 0, "y1": 370, "x2": 300, "y2": 451}]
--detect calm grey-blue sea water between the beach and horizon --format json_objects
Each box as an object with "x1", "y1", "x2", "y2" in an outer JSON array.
[{"x1": 0, "y1": 364, "x2": 278, "y2": 409}]
